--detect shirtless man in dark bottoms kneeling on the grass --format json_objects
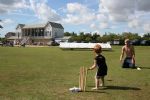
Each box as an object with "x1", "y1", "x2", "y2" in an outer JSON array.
[{"x1": 120, "y1": 39, "x2": 135, "y2": 68}]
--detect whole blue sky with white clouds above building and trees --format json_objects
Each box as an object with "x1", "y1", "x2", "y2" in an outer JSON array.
[{"x1": 0, "y1": 0, "x2": 150, "y2": 37}]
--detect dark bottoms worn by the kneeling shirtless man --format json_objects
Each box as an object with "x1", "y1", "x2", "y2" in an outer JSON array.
[{"x1": 122, "y1": 57, "x2": 135, "y2": 68}]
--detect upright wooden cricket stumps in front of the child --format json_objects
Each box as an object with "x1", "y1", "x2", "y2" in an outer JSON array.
[{"x1": 79, "y1": 67, "x2": 87, "y2": 92}]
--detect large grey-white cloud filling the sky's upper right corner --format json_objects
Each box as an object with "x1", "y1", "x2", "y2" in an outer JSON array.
[{"x1": 99, "y1": 0, "x2": 150, "y2": 22}]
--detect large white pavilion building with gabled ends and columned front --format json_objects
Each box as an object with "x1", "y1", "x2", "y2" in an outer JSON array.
[{"x1": 5, "y1": 22, "x2": 64, "y2": 44}]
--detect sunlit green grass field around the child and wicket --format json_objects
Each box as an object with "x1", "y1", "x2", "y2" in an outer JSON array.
[{"x1": 0, "y1": 46, "x2": 150, "y2": 100}]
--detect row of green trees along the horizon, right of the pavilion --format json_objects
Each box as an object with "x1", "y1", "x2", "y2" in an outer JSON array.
[{"x1": 64, "y1": 32, "x2": 150, "y2": 45}]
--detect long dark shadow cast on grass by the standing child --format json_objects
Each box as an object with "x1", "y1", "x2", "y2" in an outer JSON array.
[{"x1": 103, "y1": 86, "x2": 141, "y2": 90}]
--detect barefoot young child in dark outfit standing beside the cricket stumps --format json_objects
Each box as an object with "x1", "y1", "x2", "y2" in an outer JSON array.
[{"x1": 88, "y1": 44, "x2": 107, "y2": 89}]
